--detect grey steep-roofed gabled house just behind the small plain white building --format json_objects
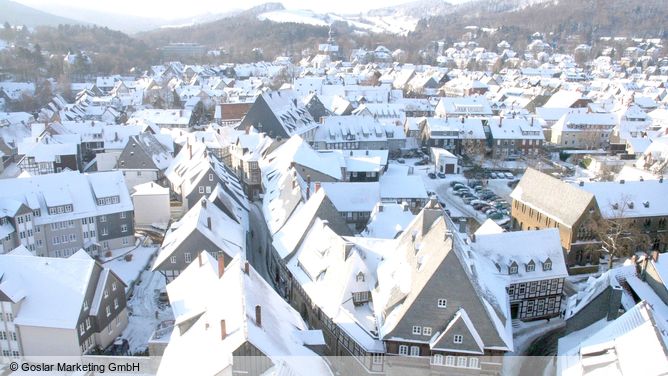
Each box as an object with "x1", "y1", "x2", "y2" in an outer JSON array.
[{"x1": 116, "y1": 132, "x2": 172, "y2": 188}]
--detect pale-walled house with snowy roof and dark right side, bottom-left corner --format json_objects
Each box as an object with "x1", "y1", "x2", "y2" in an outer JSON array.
[{"x1": 0, "y1": 246, "x2": 128, "y2": 359}]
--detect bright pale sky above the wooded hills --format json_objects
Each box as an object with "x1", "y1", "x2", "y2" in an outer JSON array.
[{"x1": 14, "y1": 0, "x2": 464, "y2": 19}]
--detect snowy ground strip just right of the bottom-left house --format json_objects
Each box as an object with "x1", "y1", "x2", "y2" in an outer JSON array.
[{"x1": 122, "y1": 270, "x2": 174, "y2": 354}]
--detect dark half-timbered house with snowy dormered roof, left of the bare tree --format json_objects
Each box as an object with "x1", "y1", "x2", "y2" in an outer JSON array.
[{"x1": 471, "y1": 223, "x2": 568, "y2": 321}]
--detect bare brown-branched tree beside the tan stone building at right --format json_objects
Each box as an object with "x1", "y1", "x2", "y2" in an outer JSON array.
[{"x1": 591, "y1": 195, "x2": 649, "y2": 269}]
